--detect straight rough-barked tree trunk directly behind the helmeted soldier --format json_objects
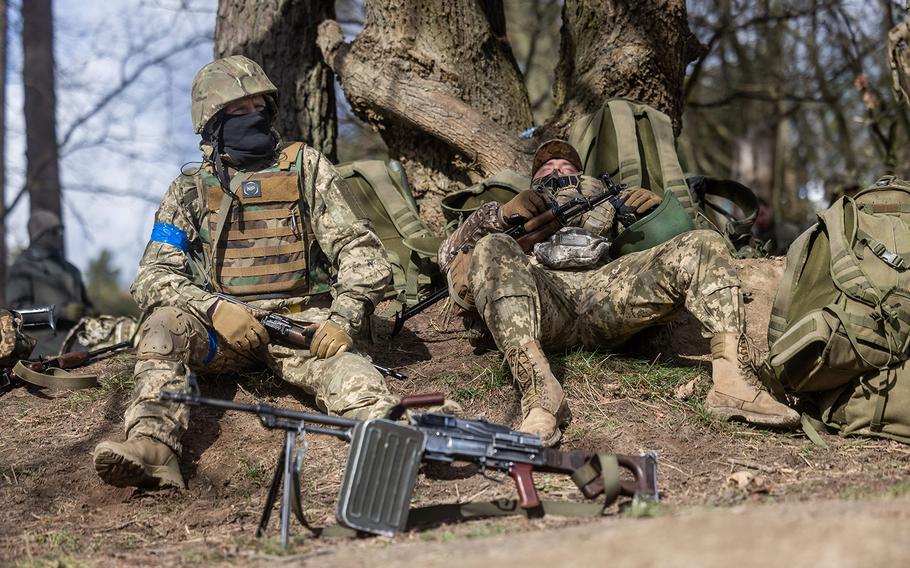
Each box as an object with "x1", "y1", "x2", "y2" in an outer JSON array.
[{"x1": 215, "y1": 0, "x2": 338, "y2": 161}]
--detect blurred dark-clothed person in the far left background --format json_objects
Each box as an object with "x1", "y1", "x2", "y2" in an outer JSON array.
[{"x1": 6, "y1": 209, "x2": 94, "y2": 356}]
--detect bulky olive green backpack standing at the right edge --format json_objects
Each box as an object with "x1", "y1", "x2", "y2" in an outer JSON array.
[{"x1": 762, "y1": 176, "x2": 910, "y2": 441}]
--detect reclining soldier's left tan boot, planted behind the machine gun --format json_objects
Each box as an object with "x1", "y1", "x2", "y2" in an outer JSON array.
[{"x1": 506, "y1": 340, "x2": 569, "y2": 446}]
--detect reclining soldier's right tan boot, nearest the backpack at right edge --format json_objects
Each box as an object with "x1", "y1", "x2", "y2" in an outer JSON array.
[{"x1": 705, "y1": 333, "x2": 799, "y2": 428}]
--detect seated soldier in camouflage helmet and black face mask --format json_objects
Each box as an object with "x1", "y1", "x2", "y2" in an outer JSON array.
[{"x1": 94, "y1": 55, "x2": 397, "y2": 488}]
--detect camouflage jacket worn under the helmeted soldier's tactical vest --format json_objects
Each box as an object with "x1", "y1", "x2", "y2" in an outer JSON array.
[{"x1": 131, "y1": 146, "x2": 392, "y2": 332}]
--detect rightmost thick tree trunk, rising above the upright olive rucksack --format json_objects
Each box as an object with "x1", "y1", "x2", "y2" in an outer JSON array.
[{"x1": 551, "y1": 0, "x2": 704, "y2": 135}]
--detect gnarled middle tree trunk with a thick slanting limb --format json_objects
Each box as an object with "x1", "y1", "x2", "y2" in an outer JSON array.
[{"x1": 319, "y1": 0, "x2": 532, "y2": 205}]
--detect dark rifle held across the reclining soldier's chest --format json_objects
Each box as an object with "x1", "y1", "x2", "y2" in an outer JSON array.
[{"x1": 392, "y1": 173, "x2": 626, "y2": 337}]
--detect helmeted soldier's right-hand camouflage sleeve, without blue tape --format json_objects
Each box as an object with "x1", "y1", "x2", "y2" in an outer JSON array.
[{"x1": 301, "y1": 147, "x2": 392, "y2": 333}]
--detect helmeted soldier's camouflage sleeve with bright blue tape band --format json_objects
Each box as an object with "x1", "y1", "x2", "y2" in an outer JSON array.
[{"x1": 130, "y1": 175, "x2": 216, "y2": 321}]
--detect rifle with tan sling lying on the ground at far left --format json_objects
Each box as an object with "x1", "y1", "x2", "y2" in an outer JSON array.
[{"x1": 0, "y1": 341, "x2": 133, "y2": 392}]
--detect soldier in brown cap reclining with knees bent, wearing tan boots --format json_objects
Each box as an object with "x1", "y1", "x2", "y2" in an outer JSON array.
[{"x1": 439, "y1": 140, "x2": 799, "y2": 445}]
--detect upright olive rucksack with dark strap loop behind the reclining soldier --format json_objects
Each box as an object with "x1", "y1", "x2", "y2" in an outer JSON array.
[{"x1": 569, "y1": 99, "x2": 758, "y2": 252}]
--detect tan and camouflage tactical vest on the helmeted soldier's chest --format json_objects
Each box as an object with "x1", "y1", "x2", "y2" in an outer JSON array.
[{"x1": 200, "y1": 142, "x2": 331, "y2": 296}]
